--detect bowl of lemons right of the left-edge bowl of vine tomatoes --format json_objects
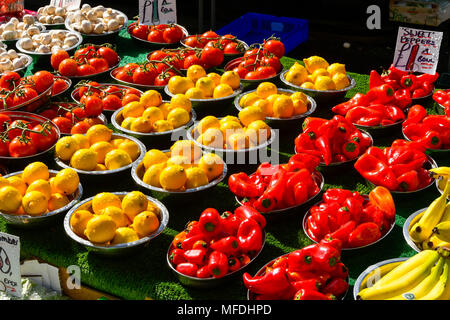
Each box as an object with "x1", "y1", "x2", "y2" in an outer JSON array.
[{"x1": 55, "y1": 124, "x2": 146, "y2": 183}]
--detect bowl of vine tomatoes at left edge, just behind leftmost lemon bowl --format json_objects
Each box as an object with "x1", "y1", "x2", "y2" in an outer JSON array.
[{"x1": 0, "y1": 111, "x2": 61, "y2": 170}]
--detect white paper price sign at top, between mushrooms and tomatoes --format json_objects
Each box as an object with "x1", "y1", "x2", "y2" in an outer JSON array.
[{"x1": 139, "y1": 0, "x2": 177, "y2": 25}]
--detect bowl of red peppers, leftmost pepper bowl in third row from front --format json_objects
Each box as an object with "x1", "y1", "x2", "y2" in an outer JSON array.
[{"x1": 295, "y1": 115, "x2": 373, "y2": 168}]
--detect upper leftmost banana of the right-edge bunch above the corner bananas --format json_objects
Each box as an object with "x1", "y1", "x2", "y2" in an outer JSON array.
[{"x1": 409, "y1": 183, "x2": 450, "y2": 242}]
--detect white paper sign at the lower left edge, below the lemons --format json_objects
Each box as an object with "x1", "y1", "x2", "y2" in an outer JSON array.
[{"x1": 0, "y1": 232, "x2": 22, "y2": 297}]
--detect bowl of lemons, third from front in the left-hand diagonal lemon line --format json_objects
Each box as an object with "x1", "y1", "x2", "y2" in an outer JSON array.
[{"x1": 111, "y1": 90, "x2": 196, "y2": 148}]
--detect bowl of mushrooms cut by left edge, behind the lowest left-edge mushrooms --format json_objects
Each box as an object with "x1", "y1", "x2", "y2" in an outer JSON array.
[{"x1": 0, "y1": 14, "x2": 46, "y2": 48}]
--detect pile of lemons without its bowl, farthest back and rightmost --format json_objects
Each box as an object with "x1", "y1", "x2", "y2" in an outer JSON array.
[{"x1": 285, "y1": 56, "x2": 350, "y2": 91}]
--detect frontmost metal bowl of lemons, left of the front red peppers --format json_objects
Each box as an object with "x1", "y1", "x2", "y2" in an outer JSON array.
[{"x1": 64, "y1": 191, "x2": 169, "y2": 256}]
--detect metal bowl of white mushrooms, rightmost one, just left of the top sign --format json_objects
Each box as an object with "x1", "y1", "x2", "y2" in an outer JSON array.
[{"x1": 65, "y1": 3, "x2": 128, "y2": 44}]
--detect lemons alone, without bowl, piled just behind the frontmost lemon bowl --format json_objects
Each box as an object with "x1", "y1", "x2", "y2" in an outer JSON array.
[{"x1": 141, "y1": 140, "x2": 224, "y2": 191}]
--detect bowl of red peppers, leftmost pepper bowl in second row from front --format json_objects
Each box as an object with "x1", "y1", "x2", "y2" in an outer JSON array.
[{"x1": 232, "y1": 153, "x2": 324, "y2": 218}]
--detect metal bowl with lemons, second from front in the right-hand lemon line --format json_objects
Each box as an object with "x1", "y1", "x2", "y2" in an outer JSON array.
[{"x1": 131, "y1": 140, "x2": 227, "y2": 199}]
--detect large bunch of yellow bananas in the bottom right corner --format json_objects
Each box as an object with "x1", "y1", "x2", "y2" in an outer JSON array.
[{"x1": 357, "y1": 250, "x2": 450, "y2": 300}]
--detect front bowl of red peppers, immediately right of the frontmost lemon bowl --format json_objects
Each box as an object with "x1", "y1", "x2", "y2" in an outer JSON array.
[{"x1": 167, "y1": 206, "x2": 266, "y2": 288}]
